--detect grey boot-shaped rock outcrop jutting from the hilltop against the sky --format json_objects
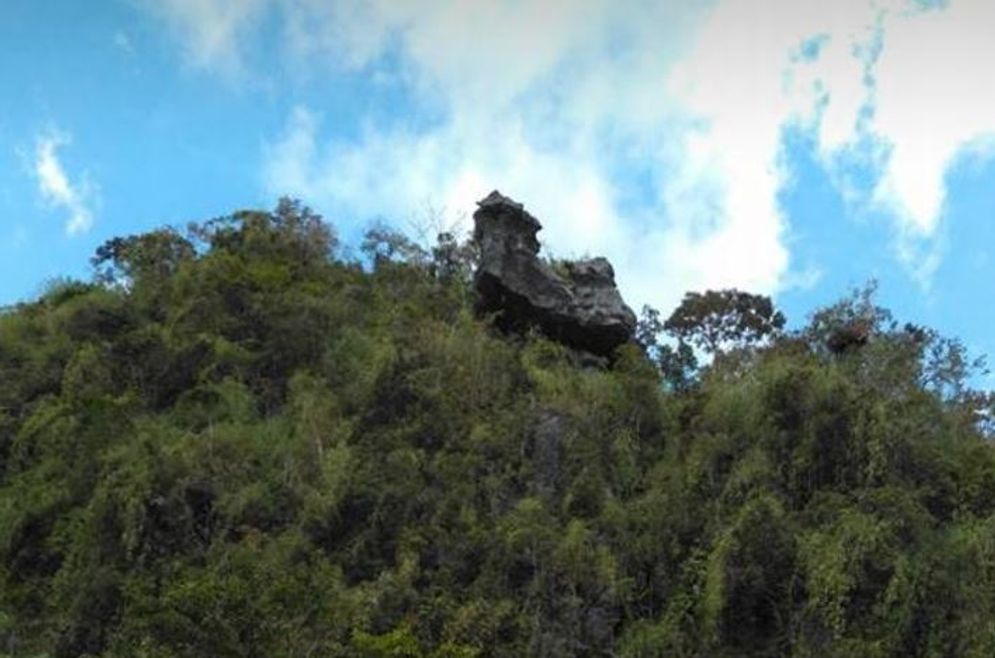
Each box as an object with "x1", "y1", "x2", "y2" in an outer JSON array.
[{"x1": 473, "y1": 190, "x2": 636, "y2": 356}]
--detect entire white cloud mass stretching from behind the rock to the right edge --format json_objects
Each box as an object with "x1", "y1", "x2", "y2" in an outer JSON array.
[{"x1": 148, "y1": 0, "x2": 995, "y2": 307}]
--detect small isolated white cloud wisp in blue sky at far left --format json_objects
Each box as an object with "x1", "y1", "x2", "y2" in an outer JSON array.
[{"x1": 33, "y1": 132, "x2": 93, "y2": 235}]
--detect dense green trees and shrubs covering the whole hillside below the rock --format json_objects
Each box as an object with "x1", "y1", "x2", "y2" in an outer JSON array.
[{"x1": 0, "y1": 202, "x2": 995, "y2": 658}]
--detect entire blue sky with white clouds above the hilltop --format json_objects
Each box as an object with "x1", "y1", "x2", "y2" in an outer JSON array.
[{"x1": 0, "y1": 0, "x2": 995, "y2": 374}]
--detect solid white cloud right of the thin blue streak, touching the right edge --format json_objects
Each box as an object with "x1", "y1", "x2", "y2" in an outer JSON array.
[{"x1": 869, "y1": 0, "x2": 995, "y2": 235}]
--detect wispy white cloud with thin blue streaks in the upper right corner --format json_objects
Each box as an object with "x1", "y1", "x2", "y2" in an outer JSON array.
[{"x1": 776, "y1": 0, "x2": 995, "y2": 287}]
